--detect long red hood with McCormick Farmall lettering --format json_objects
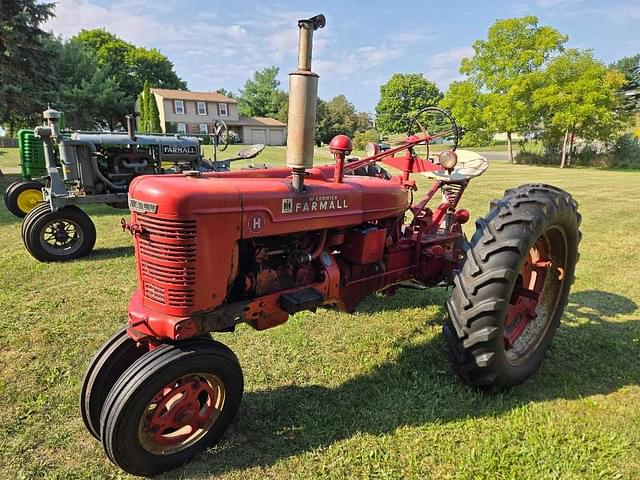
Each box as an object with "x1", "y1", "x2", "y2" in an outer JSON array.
[{"x1": 129, "y1": 166, "x2": 409, "y2": 238}]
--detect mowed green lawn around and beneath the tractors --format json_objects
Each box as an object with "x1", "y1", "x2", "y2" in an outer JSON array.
[{"x1": 0, "y1": 147, "x2": 640, "y2": 479}]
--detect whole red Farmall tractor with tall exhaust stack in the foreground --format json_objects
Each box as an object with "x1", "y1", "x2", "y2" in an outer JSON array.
[{"x1": 81, "y1": 15, "x2": 580, "y2": 475}]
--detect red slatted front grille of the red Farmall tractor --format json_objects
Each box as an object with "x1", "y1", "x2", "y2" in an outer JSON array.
[{"x1": 137, "y1": 215, "x2": 196, "y2": 314}]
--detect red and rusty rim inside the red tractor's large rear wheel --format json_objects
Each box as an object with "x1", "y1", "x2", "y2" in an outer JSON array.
[{"x1": 503, "y1": 232, "x2": 566, "y2": 363}]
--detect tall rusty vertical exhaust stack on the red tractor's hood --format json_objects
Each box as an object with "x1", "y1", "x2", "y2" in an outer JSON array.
[{"x1": 287, "y1": 15, "x2": 326, "y2": 192}]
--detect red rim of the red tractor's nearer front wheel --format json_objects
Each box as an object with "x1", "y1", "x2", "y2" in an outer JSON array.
[{"x1": 138, "y1": 373, "x2": 225, "y2": 455}]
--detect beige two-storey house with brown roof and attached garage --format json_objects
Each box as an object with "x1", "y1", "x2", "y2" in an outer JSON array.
[{"x1": 151, "y1": 88, "x2": 287, "y2": 145}]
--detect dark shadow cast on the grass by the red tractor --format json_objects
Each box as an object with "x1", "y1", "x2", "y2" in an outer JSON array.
[{"x1": 174, "y1": 291, "x2": 640, "y2": 478}]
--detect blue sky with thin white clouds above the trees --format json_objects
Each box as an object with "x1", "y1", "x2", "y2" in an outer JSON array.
[{"x1": 46, "y1": 0, "x2": 640, "y2": 112}]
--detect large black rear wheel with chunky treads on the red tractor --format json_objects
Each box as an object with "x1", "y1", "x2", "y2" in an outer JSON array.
[{"x1": 444, "y1": 184, "x2": 581, "y2": 391}]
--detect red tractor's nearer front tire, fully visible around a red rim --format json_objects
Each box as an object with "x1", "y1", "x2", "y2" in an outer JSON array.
[{"x1": 101, "y1": 339, "x2": 244, "y2": 475}]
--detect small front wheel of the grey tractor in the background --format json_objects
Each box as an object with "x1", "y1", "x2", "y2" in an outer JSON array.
[{"x1": 22, "y1": 204, "x2": 96, "y2": 262}]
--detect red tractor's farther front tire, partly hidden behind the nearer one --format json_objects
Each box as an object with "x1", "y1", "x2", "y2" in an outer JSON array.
[{"x1": 80, "y1": 327, "x2": 147, "y2": 440}]
